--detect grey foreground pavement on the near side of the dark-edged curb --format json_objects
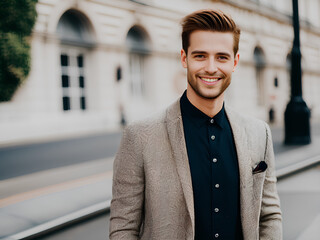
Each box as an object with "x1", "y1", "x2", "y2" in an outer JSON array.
[{"x1": 38, "y1": 165, "x2": 320, "y2": 240}]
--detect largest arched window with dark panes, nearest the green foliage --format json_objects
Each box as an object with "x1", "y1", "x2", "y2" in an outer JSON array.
[{"x1": 57, "y1": 10, "x2": 94, "y2": 111}]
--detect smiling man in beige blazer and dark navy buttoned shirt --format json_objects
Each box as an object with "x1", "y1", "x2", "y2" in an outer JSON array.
[{"x1": 110, "y1": 10, "x2": 282, "y2": 240}]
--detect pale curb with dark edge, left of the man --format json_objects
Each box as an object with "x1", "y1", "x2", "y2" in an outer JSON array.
[{"x1": 3, "y1": 200, "x2": 111, "y2": 240}]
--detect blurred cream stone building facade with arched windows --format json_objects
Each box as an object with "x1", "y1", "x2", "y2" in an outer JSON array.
[{"x1": 0, "y1": 0, "x2": 320, "y2": 142}]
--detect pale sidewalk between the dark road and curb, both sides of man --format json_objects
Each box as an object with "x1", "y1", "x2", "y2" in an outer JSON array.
[{"x1": 0, "y1": 131, "x2": 320, "y2": 240}]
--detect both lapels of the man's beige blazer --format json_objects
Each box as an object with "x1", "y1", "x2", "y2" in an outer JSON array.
[{"x1": 166, "y1": 100, "x2": 254, "y2": 239}]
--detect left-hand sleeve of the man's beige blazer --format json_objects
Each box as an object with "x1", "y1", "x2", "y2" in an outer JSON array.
[{"x1": 109, "y1": 126, "x2": 144, "y2": 240}]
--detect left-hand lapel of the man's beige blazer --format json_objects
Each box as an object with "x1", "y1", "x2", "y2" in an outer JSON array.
[{"x1": 166, "y1": 100, "x2": 194, "y2": 234}]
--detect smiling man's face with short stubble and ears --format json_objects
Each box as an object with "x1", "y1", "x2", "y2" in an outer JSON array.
[{"x1": 181, "y1": 30, "x2": 239, "y2": 99}]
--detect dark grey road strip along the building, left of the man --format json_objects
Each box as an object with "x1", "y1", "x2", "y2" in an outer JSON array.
[{"x1": 0, "y1": 132, "x2": 121, "y2": 181}]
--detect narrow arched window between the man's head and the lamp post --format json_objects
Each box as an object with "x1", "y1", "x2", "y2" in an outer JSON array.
[{"x1": 253, "y1": 47, "x2": 266, "y2": 106}]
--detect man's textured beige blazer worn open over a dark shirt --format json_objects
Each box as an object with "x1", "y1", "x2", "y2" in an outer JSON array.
[{"x1": 110, "y1": 101, "x2": 282, "y2": 240}]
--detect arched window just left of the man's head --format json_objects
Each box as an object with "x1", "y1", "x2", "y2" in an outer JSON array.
[{"x1": 126, "y1": 26, "x2": 150, "y2": 97}]
